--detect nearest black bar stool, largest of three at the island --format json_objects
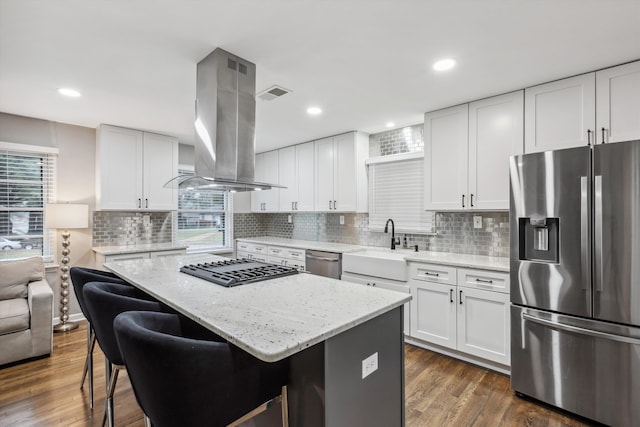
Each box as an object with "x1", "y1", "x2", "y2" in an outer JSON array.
[{"x1": 113, "y1": 311, "x2": 288, "y2": 427}]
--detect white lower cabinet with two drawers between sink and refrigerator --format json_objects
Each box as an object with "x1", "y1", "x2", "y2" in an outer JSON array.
[{"x1": 409, "y1": 264, "x2": 511, "y2": 366}]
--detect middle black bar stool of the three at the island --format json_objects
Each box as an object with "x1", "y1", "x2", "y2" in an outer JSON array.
[{"x1": 82, "y1": 282, "x2": 163, "y2": 427}]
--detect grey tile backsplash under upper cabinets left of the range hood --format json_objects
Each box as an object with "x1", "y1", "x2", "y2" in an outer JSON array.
[{"x1": 93, "y1": 211, "x2": 175, "y2": 246}]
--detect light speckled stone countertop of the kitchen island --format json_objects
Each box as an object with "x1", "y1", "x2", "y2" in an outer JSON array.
[{"x1": 105, "y1": 254, "x2": 411, "y2": 362}]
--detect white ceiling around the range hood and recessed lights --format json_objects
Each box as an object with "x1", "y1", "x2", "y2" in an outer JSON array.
[{"x1": 0, "y1": 0, "x2": 640, "y2": 151}]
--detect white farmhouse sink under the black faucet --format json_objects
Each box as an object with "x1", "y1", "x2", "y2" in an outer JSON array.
[{"x1": 342, "y1": 248, "x2": 412, "y2": 282}]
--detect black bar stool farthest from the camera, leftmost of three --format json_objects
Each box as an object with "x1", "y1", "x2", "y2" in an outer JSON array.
[{"x1": 69, "y1": 267, "x2": 127, "y2": 409}]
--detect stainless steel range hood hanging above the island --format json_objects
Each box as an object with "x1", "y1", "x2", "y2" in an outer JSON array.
[{"x1": 165, "y1": 48, "x2": 283, "y2": 191}]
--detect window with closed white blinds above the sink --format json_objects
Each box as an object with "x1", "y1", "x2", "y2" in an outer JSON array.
[{"x1": 367, "y1": 152, "x2": 435, "y2": 234}]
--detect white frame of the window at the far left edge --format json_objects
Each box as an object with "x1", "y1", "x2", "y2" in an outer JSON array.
[{"x1": 0, "y1": 141, "x2": 59, "y2": 263}]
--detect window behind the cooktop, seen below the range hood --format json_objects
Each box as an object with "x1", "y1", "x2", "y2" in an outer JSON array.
[{"x1": 177, "y1": 170, "x2": 233, "y2": 252}]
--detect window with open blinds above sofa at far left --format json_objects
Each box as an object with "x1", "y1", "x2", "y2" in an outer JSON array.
[{"x1": 0, "y1": 142, "x2": 57, "y2": 260}]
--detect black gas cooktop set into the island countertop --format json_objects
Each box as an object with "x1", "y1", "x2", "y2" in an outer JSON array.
[{"x1": 180, "y1": 259, "x2": 298, "y2": 288}]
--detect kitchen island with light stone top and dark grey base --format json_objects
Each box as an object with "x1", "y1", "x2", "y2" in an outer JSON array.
[{"x1": 105, "y1": 254, "x2": 411, "y2": 426}]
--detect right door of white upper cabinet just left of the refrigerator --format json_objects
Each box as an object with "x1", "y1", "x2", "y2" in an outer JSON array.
[{"x1": 469, "y1": 91, "x2": 524, "y2": 210}]
